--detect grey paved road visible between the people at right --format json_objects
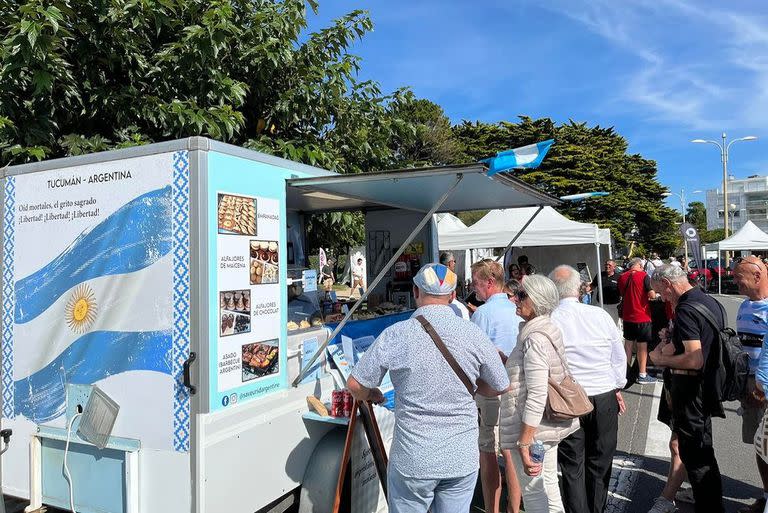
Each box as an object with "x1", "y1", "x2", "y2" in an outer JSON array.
[{"x1": 609, "y1": 296, "x2": 762, "y2": 513}]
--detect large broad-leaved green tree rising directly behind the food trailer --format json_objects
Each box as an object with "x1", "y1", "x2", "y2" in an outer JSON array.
[{"x1": 0, "y1": 0, "x2": 432, "y2": 255}]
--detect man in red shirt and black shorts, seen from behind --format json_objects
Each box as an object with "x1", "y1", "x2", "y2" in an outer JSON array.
[{"x1": 618, "y1": 258, "x2": 656, "y2": 383}]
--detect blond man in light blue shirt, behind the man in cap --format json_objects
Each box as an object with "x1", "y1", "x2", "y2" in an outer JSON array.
[{"x1": 472, "y1": 259, "x2": 523, "y2": 513}]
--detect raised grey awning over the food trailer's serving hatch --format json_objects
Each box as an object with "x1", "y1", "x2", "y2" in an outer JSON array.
[{"x1": 287, "y1": 164, "x2": 560, "y2": 212}]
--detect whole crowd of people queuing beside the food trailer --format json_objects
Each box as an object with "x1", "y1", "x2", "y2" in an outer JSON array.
[{"x1": 348, "y1": 254, "x2": 768, "y2": 513}]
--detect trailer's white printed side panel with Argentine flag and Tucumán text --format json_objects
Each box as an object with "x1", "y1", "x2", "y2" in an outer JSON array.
[{"x1": 2, "y1": 152, "x2": 189, "y2": 450}]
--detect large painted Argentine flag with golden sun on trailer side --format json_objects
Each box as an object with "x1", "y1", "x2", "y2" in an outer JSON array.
[{"x1": 13, "y1": 186, "x2": 173, "y2": 423}]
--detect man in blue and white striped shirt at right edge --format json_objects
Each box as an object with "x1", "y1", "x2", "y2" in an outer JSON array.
[{"x1": 733, "y1": 256, "x2": 768, "y2": 513}]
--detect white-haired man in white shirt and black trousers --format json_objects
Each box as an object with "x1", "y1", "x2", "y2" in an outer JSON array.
[{"x1": 549, "y1": 265, "x2": 627, "y2": 513}]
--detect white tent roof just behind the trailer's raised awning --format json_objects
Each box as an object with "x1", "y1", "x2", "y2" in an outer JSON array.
[{"x1": 440, "y1": 207, "x2": 610, "y2": 249}]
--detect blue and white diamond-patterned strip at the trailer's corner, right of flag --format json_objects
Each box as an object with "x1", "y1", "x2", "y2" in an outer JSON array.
[{"x1": 172, "y1": 151, "x2": 190, "y2": 452}]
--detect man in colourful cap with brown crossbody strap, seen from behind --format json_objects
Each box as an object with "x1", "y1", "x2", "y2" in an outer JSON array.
[{"x1": 347, "y1": 264, "x2": 509, "y2": 513}]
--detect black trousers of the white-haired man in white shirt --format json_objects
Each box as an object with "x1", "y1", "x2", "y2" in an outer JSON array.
[{"x1": 557, "y1": 391, "x2": 619, "y2": 513}]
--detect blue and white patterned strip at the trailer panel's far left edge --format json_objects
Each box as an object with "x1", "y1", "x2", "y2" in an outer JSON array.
[{"x1": 2, "y1": 176, "x2": 16, "y2": 419}]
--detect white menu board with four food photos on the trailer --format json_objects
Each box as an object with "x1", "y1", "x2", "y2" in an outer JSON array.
[{"x1": 216, "y1": 191, "x2": 282, "y2": 403}]
